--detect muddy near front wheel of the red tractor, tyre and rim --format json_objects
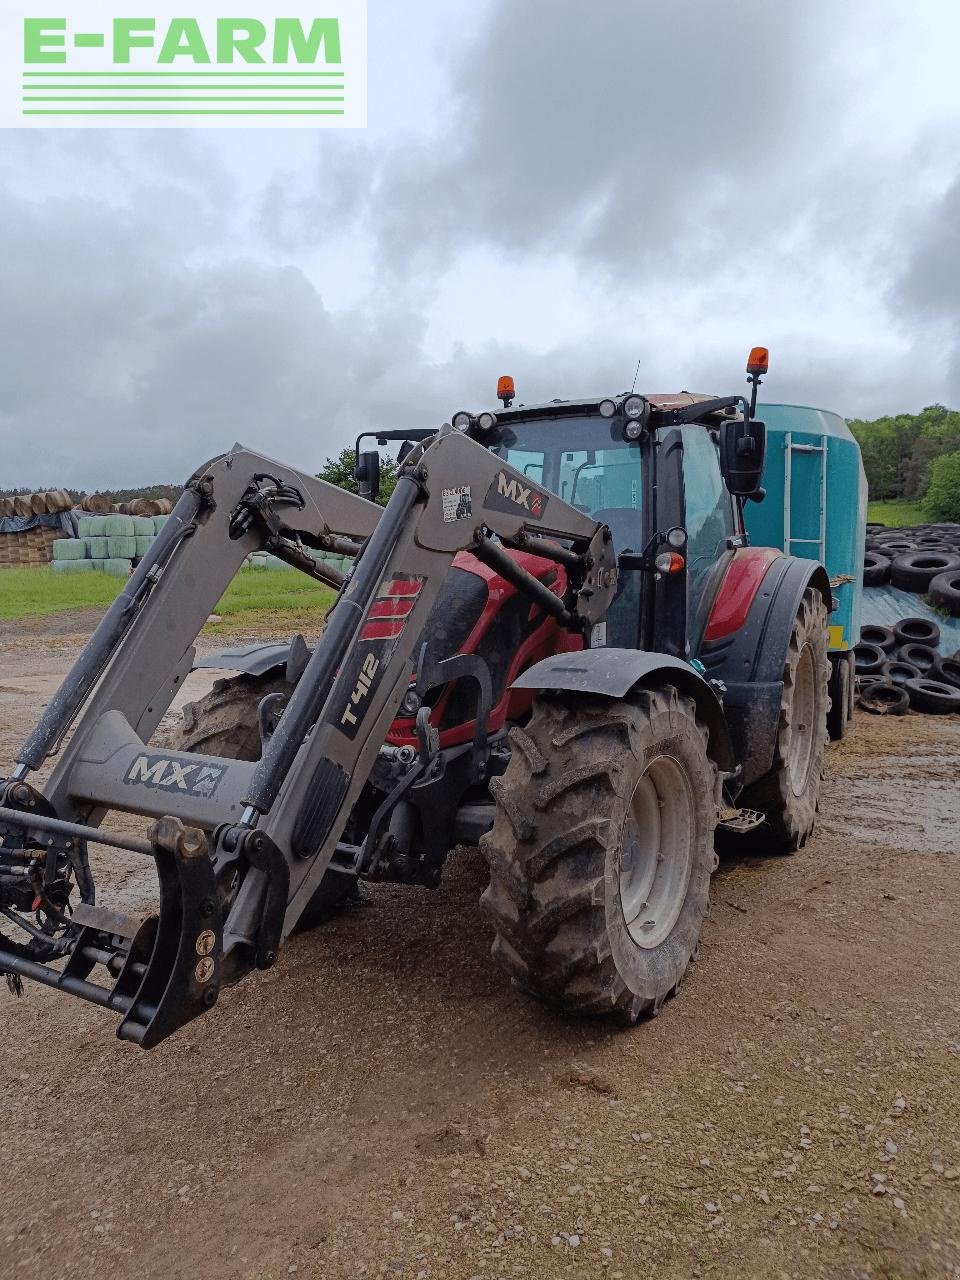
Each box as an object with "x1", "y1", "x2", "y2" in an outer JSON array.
[{"x1": 481, "y1": 686, "x2": 721, "y2": 1023}]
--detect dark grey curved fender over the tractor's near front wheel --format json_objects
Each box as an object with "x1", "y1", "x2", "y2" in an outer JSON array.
[{"x1": 511, "y1": 649, "x2": 736, "y2": 773}]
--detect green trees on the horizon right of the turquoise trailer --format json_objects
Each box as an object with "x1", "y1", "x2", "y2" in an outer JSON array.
[{"x1": 849, "y1": 404, "x2": 960, "y2": 520}]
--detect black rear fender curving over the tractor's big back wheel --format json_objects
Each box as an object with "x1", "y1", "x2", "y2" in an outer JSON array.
[{"x1": 698, "y1": 556, "x2": 833, "y2": 787}]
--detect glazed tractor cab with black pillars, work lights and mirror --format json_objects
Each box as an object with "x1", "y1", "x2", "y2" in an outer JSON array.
[{"x1": 453, "y1": 374, "x2": 764, "y2": 658}]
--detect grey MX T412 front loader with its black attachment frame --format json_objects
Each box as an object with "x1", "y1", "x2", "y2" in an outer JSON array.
[{"x1": 0, "y1": 428, "x2": 617, "y2": 1047}]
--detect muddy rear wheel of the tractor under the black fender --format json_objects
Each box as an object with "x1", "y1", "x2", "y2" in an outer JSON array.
[{"x1": 739, "y1": 586, "x2": 829, "y2": 852}]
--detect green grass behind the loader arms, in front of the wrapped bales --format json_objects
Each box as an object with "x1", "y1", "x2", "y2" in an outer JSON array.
[{"x1": 0, "y1": 568, "x2": 334, "y2": 631}]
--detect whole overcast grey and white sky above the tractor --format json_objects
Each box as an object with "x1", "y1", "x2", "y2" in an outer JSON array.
[{"x1": 0, "y1": 0, "x2": 960, "y2": 489}]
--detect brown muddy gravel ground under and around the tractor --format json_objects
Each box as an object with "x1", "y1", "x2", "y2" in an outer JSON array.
[{"x1": 0, "y1": 618, "x2": 960, "y2": 1280}]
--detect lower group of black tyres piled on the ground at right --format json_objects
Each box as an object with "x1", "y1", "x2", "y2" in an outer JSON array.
[{"x1": 854, "y1": 618, "x2": 960, "y2": 716}]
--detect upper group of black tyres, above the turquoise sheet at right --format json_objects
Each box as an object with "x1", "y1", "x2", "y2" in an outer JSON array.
[{"x1": 863, "y1": 525, "x2": 960, "y2": 618}]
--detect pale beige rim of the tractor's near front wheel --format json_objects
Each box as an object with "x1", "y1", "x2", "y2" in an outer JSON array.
[{"x1": 620, "y1": 755, "x2": 695, "y2": 950}]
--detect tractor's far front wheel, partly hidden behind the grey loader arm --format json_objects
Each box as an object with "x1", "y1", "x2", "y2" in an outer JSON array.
[{"x1": 170, "y1": 676, "x2": 357, "y2": 929}]
